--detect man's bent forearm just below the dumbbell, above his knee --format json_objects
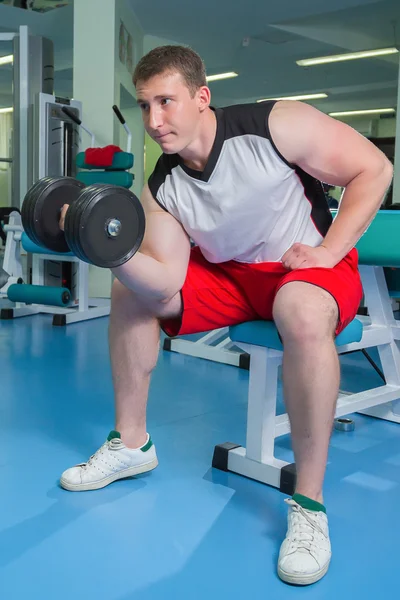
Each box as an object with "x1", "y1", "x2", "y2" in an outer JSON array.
[{"x1": 112, "y1": 252, "x2": 181, "y2": 302}]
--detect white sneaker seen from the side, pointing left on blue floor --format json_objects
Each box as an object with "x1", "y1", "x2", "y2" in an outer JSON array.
[{"x1": 60, "y1": 431, "x2": 158, "y2": 492}]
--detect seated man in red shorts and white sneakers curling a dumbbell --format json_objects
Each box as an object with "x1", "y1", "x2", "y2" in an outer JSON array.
[{"x1": 61, "y1": 46, "x2": 392, "y2": 584}]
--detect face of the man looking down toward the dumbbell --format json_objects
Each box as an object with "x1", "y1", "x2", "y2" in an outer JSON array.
[{"x1": 136, "y1": 72, "x2": 206, "y2": 154}]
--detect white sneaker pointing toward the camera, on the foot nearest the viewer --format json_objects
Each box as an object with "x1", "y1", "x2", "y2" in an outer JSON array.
[{"x1": 278, "y1": 499, "x2": 332, "y2": 585}]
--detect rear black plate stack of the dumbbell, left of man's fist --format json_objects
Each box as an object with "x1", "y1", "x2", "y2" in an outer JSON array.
[{"x1": 24, "y1": 177, "x2": 85, "y2": 252}]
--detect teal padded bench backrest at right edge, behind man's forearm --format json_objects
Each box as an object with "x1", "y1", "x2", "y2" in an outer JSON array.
[{"x1": 332, "y1": 210, "x2": 400, "y2": 267}]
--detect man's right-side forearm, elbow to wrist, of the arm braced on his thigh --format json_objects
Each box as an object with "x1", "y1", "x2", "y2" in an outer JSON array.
[{"x1": 321, "y1": 163, "x2": 393, "y2": 264}]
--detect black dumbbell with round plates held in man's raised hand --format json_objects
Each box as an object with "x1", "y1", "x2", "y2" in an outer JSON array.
[{"x1": 21, "y1": 177, "x2": 145, "y2": 268}]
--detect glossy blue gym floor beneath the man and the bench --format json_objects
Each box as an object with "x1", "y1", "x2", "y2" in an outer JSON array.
[{"x1": 0, "y1": 316, "x2": 400, "y2": 600}]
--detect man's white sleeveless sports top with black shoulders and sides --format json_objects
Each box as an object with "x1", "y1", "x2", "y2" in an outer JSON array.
[{"x1": 148, "y1": 101, "x2": 332, "y2": 263}]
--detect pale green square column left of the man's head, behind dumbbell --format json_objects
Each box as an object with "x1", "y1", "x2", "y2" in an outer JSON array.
[{"x1": 73, "y1": 0, "x2": 144, "y2": 297}]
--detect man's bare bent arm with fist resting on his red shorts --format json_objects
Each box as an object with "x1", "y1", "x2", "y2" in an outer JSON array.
[{"x1": 269, "y1": 101, "x2": 393, "y2": 269}]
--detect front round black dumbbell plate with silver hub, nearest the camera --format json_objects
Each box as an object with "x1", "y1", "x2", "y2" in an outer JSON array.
[{"x1": 76, "y1": 185, "x2": 145, "y2": 268}]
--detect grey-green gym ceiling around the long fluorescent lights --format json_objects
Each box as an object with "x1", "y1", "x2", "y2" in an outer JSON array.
[{"x1": 0, "y1": 0, "x2": 400, "y2": 118}]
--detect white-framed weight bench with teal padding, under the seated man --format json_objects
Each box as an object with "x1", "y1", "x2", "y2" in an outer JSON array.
[{"x1": 212, "y1": 210, "x2": 400, "y2": 495}]
